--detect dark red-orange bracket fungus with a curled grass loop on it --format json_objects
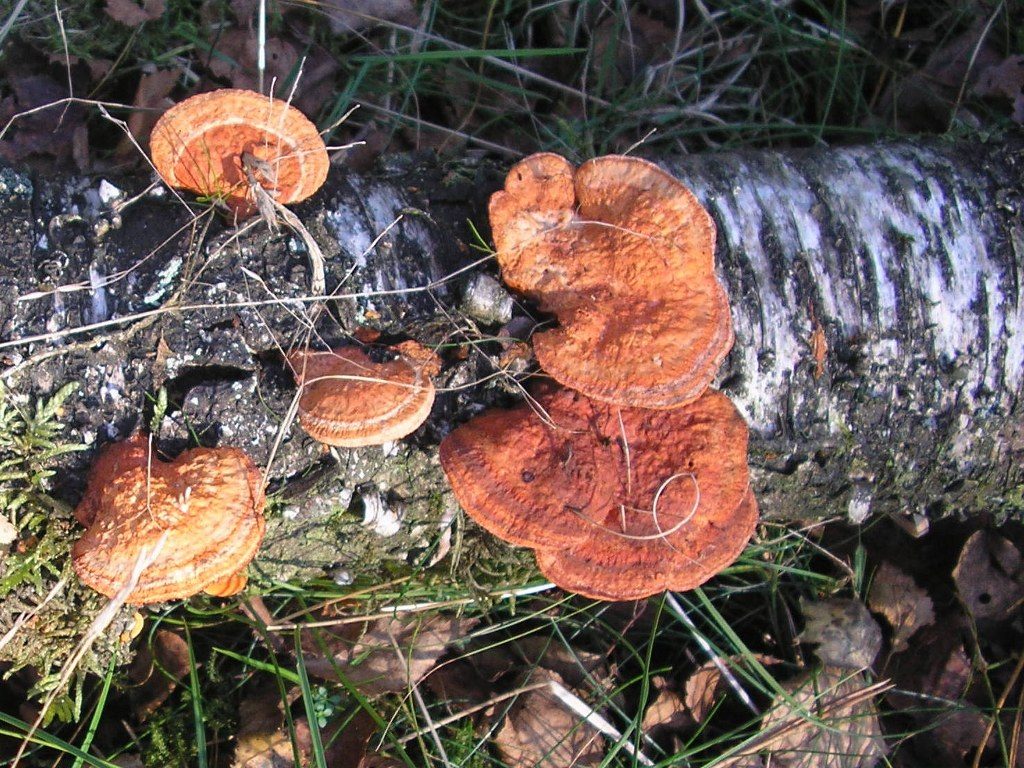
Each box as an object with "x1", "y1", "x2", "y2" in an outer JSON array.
[{"x1": 440, "y1": 389, "x2": 758, "y2": 600}]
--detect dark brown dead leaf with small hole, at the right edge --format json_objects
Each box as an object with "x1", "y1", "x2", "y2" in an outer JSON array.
[{"x1": 953, "y1": 530, "x2": 1024, "y2": 621}]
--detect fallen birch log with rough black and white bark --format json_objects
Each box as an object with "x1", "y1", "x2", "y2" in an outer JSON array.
[{"x1": 0, "y1": 135, "x2": 1024, "y2": 581}]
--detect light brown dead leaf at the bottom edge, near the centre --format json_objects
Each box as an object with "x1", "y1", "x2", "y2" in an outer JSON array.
[{"x1": 495, "y1": 668, "x2": 604, "y2": 768}]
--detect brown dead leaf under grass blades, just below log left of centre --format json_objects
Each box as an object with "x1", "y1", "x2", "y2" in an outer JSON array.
[{"x1": 303, "y1": 615, "x2": 476, "y2": 696}]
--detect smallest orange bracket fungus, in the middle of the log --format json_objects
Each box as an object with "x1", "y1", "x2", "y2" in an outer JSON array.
[{"x1": 288, "y1": 341, "x2": 439, "y2": 447}]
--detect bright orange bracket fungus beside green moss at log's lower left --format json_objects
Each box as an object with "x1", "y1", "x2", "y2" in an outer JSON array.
[{"x1": 72, "y1": 435, "x2": 265, "y2": 605}]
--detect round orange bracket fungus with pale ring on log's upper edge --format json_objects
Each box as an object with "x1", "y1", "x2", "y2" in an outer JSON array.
[{"x1": 150, "y1": 88, "x2": 330, "y2": 218}]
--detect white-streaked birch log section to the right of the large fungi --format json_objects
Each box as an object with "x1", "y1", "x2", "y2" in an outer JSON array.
[{"x1": 669, "y1": 137, "x2": 1024, "y2": 519}]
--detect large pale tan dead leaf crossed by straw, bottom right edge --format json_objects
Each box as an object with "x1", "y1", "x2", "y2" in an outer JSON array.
[{"x1": 762, "y1": 667, "x2": 886, "y2": 768}]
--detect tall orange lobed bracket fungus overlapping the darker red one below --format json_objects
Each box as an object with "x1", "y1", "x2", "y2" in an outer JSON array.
[{"x1": 489, "y1": 153, "x2": 733, "y2": 409}]
